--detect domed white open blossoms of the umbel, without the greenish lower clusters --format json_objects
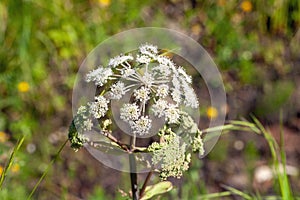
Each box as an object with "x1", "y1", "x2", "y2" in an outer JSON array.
[{"x1": 79, "y1": 44, "x2": 199, "y2": 135}]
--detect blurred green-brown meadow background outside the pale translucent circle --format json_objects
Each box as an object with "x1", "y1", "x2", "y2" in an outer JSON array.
[{"x1": 0, "y1": 0, "x2": 300, "y2": 199}]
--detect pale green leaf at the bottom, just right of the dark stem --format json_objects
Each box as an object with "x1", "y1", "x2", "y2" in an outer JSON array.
[{"x1": 140, "y1": 181, "x2": 173, "y2": 200}]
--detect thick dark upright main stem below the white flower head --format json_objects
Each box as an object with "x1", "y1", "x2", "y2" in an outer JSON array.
[{"x1": 129, "y1": 153, "x2": 139, "y2": 200}]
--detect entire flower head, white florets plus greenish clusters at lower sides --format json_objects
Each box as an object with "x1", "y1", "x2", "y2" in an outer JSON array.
[{"x1": 70, "y1": 44, "x2": 204, "y2": 180}]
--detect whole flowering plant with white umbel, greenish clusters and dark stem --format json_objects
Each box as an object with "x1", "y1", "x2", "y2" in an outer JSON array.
[{"x1": 69, "y1": 44, "x2": 204, "y2": 199}]
